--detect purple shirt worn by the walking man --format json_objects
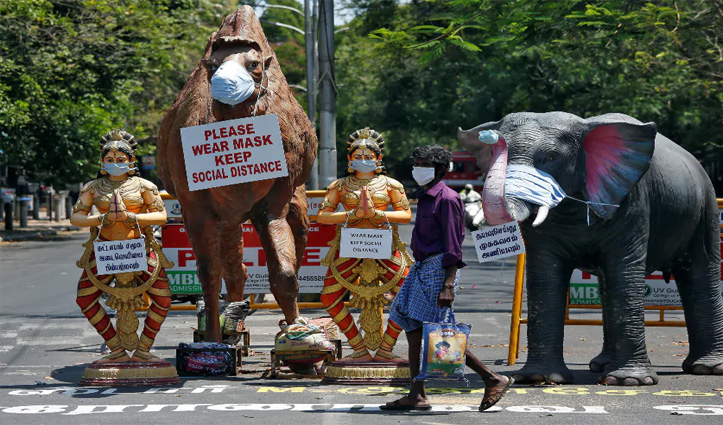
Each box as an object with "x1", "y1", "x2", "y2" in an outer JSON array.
[{"x1": 410, "y1": 181, "x2": 465, "y2": 269}]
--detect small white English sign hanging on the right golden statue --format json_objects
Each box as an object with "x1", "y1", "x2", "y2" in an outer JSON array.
[{"x1": 339, "y1": 227, "x2": 392, "y2": 260}]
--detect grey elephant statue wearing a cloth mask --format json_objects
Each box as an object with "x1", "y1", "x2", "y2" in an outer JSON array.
[{"x1": 457, "y1": 112, "x2": 723, "y2": 385}]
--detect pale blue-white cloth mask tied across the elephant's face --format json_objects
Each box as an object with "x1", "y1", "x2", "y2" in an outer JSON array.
[{"x1": 505, "y1": 164, "x2": 567, "y2": 208}]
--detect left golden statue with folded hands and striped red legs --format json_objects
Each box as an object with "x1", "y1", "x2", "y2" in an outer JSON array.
[{"x1": 70, "y1": 130, "x2": 178, "y2": 368}]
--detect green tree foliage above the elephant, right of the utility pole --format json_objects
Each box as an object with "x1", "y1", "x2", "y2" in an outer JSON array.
[{"x1": 337, "y1": 0, "x2": 723, "y2": 186}]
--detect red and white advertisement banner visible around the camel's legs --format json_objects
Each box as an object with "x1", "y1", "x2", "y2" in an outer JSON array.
[{"x1": 163, "y1": 223, "x2": 336, "y2": 294}]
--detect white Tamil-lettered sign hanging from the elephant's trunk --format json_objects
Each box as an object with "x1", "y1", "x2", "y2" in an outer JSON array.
[{"x1": 472, "y1": 221, "x2": 525, "y2": 263}]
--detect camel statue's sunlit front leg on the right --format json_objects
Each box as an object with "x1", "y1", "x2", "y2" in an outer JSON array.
[{"x1": 251, "y1": 198, "x2": 299, "y2": 324}]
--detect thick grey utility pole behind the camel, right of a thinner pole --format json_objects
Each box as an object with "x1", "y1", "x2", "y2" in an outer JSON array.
[{"x1": 319, "y1": 0, "x2": 336, "y2": 187}]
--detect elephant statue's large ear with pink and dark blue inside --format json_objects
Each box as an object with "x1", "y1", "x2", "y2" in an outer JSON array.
[{"x1": 583, "y1": 114, "x2": 657, "y2": 220}]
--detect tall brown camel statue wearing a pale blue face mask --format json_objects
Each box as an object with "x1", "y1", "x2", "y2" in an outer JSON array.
[{"x1": 156, "y1": 6, "x2": 317, "y2": 342}]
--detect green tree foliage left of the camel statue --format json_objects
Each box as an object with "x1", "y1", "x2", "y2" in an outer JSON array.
[{"x1": 0, "y1": 0, "x2": 225, "y2": 184}]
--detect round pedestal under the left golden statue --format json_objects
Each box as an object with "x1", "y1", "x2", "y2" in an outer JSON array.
[{"x1": 78, "y1": 360, "x2": 181, "y2": 387}]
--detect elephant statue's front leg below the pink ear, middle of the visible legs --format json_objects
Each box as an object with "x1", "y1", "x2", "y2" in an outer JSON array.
[{"x1": 600, "y1": 258, "x2": 658, "y2": 385}]
